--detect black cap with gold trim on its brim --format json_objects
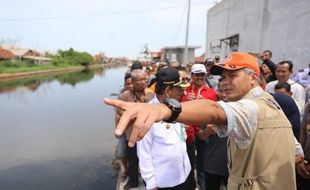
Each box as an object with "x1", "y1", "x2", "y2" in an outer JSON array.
[{"x1": 156, "y1": 67, "x2": 189, "y2": 88}]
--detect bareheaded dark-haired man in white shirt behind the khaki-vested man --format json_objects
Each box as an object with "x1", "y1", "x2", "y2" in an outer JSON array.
[{"x1": 266, "y1": 61, "x2": 306, "y2": 114}]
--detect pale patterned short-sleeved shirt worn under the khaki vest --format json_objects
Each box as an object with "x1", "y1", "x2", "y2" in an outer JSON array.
[{"x1": 216, "y1": 87, "x2": 303, "y2": 155}]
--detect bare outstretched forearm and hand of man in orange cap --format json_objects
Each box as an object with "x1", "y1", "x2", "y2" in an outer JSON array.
[{"x1": 104, "y1": 99, "x2": 226, "y2": 146}]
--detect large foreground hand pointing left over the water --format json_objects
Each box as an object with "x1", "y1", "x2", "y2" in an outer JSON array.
[{"x1": 104, "y1": 98, "x2": 171, "y2": 147}]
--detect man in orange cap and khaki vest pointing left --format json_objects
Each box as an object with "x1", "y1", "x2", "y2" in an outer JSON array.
[{"x1": 105, "y1": 52, "x2": 310, "y2": 190}]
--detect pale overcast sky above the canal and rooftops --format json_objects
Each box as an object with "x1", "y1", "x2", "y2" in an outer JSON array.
[{"x1": 0, "y1": 0, "x2": 215, "y2": 58}]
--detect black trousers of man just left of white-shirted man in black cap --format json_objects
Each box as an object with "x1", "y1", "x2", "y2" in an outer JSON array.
[{"x1": 126, "y1": 140, "x2": 139, "y2": 187}]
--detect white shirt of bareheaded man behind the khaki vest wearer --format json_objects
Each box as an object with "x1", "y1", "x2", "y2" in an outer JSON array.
[{"x1": 266, "y1": 79, "x2": 306, "y2": 115}]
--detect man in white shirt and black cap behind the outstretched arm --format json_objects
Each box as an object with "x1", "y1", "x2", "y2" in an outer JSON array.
[{"x1": 137, "y1": 67, "x2": 191, "y2": 190}]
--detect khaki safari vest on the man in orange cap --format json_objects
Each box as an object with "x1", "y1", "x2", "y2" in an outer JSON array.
[{"x1": 228, "y1": 93, "x2": 296, "y2": 190}]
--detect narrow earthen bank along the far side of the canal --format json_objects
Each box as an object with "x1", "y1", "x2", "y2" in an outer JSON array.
[{"x1": 0, "y1": 63, "x2": 125, "y2": 81}]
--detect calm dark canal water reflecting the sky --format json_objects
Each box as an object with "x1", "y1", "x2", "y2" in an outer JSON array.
[{"x1": 0, "y1": 67, "x2": 127, "y2": 190}]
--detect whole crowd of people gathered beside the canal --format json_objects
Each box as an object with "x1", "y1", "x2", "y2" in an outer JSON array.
[{"x1": 105, "y1": 50, "x2": 310, "y2": 190}]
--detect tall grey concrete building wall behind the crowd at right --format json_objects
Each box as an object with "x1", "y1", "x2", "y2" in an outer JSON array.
[{"x1": 206, "y1": 0, "x2": 310, "y2": 71}]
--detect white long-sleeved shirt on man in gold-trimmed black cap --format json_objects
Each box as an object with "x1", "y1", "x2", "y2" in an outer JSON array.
[{"x1": 137, "y1": 97, "x2": 191, "y2": 189}]
